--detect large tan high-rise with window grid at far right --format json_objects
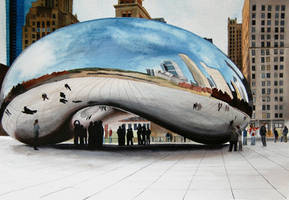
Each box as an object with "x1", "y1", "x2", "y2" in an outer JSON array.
[{"x1": 242, "y1": 0, "x2": 289, "y2": 129}]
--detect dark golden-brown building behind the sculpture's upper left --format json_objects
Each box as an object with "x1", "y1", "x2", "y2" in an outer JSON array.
[{"x1": 22, "y1": 0, "x2": 78, "y2": 49}]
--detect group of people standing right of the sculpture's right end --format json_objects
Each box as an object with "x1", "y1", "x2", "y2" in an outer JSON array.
[{"x1": 229, "y1": 121, "x2": 288, "y2": 151}]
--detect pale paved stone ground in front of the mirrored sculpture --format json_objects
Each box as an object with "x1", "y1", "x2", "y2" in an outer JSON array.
[{"x1": 0, "y1": 137, "x2": 289, "y2": 200}]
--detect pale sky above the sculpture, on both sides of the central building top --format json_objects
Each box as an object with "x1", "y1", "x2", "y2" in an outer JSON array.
[{"x1": 74, "y1": 0, "x2": 243, "y2": 54}]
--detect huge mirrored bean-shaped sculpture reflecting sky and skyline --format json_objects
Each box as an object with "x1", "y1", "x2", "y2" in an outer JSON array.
[{"x1": 1, "y1": 18, "x2": 251, "y2": 144}]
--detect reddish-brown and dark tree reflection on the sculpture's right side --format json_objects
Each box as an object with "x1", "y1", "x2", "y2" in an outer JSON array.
[{"x1": 178, "y1": 82, "x2": 252, "y2": 116}]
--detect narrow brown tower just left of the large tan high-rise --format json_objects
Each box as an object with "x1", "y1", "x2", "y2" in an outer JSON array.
[{"x1": 228, "y1": 18, "x2": 242, "y2": 69}]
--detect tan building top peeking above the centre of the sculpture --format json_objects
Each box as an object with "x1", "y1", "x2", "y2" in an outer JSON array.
[{"x1": 114, "y1": 0, "x2": 151, "y2": 19}]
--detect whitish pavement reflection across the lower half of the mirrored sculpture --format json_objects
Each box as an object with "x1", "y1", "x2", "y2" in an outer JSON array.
[{"x1": 2, "y1": 77, "x2": 249, "y2": 144}]
